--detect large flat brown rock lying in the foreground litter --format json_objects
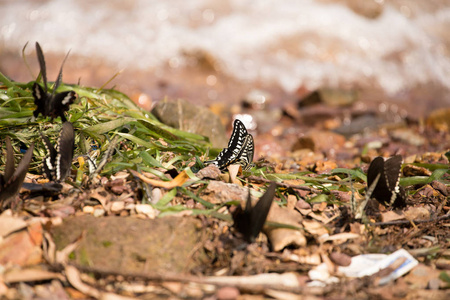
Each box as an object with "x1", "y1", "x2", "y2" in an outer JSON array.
[{"x1": 51, "y1": 215, "x2": 206, "y2": 274}]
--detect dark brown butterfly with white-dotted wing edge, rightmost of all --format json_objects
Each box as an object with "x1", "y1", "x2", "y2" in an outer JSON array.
[{"x1": 367, "y1": 155, "x2": 406, "y2": 207}]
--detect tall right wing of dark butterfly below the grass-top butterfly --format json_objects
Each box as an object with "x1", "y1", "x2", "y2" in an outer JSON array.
[{"x1": 56, "y1": 122, "x2": 75, "y2": 180}]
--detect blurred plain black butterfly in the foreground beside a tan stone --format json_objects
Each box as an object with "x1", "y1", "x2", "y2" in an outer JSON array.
[{"x1": 233, "y1": 182, "x2": 276, "y2": 243}]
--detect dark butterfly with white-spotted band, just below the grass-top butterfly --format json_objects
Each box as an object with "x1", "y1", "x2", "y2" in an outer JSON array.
[{"x1": 42, "y1": 122, "x2": 75, "y2": 181}]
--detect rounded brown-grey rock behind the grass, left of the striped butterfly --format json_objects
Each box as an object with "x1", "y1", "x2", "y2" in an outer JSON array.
[{"x1": 152, "y1": 99, "x2": 228, "y2": 148}]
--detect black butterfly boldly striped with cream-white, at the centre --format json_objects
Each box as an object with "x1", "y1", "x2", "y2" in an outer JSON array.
[{"x1": 205, "y1": 119, "x2": 255, "y2": 171}]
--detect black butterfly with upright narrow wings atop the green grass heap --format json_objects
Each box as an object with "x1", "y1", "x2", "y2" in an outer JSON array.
[{"x1": 33, "y1": 42, "x2": 76, "y2": 122}]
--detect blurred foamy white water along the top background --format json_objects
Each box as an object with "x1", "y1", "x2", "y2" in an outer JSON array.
[{"x1": 0, "y1": 0, "x2": 450, "y2": 104}]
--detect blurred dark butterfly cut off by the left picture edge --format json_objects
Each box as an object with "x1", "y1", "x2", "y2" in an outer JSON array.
[{"x1": 0, "y1": 136, "x2": 34, "y2": 208}]
